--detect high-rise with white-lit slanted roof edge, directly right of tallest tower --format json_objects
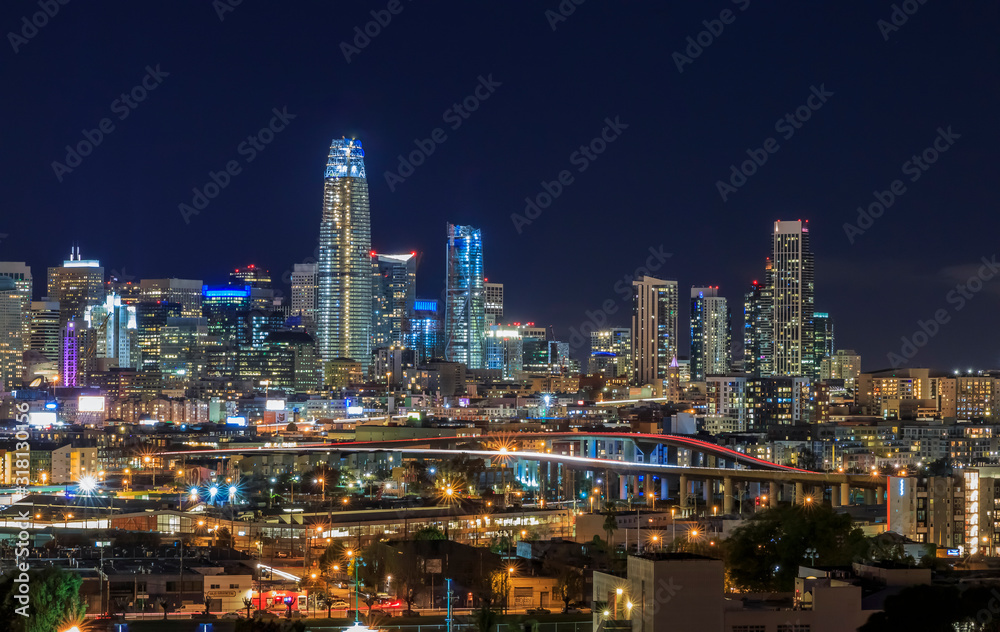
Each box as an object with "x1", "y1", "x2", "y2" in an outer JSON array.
[{"x1": 371, "y1": 252, "x2": 417, "y2": 349}]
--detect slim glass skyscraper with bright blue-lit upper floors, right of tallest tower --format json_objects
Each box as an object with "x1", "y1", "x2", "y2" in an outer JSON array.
[{"x1": 444, "y1": 224, "x2": 486, "y2": 369}]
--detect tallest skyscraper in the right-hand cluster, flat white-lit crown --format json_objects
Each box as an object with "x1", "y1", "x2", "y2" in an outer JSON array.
[{"x1": 771, "y1": 220, "x2": 818, "y2": 377}]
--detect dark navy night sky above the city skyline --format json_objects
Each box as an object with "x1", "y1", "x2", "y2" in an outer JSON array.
[{"x1": 0, "y1": 0, "x2": 1000, "y2": 370}]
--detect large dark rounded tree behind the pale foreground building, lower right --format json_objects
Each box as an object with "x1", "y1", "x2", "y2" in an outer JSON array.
[{"x1": 723, "y1": 505, "x2": 867, "y2": 592}]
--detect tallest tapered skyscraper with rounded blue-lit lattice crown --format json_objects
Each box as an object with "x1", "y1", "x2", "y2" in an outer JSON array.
[{"x1": 316, "y1": 139, "x2": 372, "y2": 368}]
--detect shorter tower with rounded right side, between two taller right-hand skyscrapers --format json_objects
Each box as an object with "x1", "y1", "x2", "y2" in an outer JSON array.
[{"x1": 691, "y1": 286, "x2": 732, "y2": 382}]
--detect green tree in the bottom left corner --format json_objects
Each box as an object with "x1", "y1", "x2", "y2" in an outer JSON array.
[{"x1": 0, "y1": 567, "x2": 86, "y2": 632}]
